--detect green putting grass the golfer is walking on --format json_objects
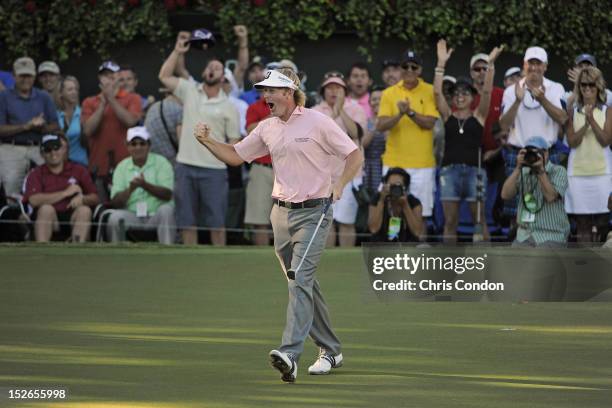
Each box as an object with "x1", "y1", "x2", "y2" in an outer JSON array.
[{"x1": 0, "y1": 245, "x2": 612, "y2": 408}]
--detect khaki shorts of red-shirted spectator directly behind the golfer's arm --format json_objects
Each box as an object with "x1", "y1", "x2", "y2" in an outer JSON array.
[{"x1": 244, "y1": 163, "x2": 274, "y2": 225}]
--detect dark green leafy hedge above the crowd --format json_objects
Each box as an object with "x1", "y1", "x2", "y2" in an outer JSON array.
[{"x1": 0, "y1": 0, "x2": 612, "y2": 64}]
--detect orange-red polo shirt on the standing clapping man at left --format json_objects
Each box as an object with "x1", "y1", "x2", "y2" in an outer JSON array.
[{"x1": 81, "y1": 89, "x2": 142, "y2": 176}]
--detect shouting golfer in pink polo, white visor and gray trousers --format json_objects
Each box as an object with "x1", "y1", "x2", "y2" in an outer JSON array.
[{"x1": 195, "y1": 69, "x2": 363, "y2": 382}]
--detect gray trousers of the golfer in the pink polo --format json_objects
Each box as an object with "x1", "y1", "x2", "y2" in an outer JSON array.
[{"x1": 270, "y1": 204, "x2": 340, "y2": 361}]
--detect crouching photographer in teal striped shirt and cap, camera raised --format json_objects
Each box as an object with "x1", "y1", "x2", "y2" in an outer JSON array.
[{"x1": 501, "y1": 136, "x2": 570, "y2": 247}]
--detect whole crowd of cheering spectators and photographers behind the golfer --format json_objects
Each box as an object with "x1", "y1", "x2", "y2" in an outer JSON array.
[{"x1": 0, "y1": 26, "x2": 612, "y2": 246}]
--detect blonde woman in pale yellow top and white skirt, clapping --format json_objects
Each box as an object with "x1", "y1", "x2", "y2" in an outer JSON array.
[{"x1": 565, "y1": 67, "x2": 612, "y2": 242}]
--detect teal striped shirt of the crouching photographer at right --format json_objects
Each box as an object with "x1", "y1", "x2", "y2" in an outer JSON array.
[{"x1": 516, "y1": 161, "x2": 570, "y2": 245}]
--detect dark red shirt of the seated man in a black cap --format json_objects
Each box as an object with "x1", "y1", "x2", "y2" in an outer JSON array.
[{"x1": 23, "y1": 161, "x2": 96, "y2": 213}]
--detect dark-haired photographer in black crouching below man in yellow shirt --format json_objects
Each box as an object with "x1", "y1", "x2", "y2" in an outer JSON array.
[{"x1": 368, "y1": 167, "x2": 425, "y2": 242}]
